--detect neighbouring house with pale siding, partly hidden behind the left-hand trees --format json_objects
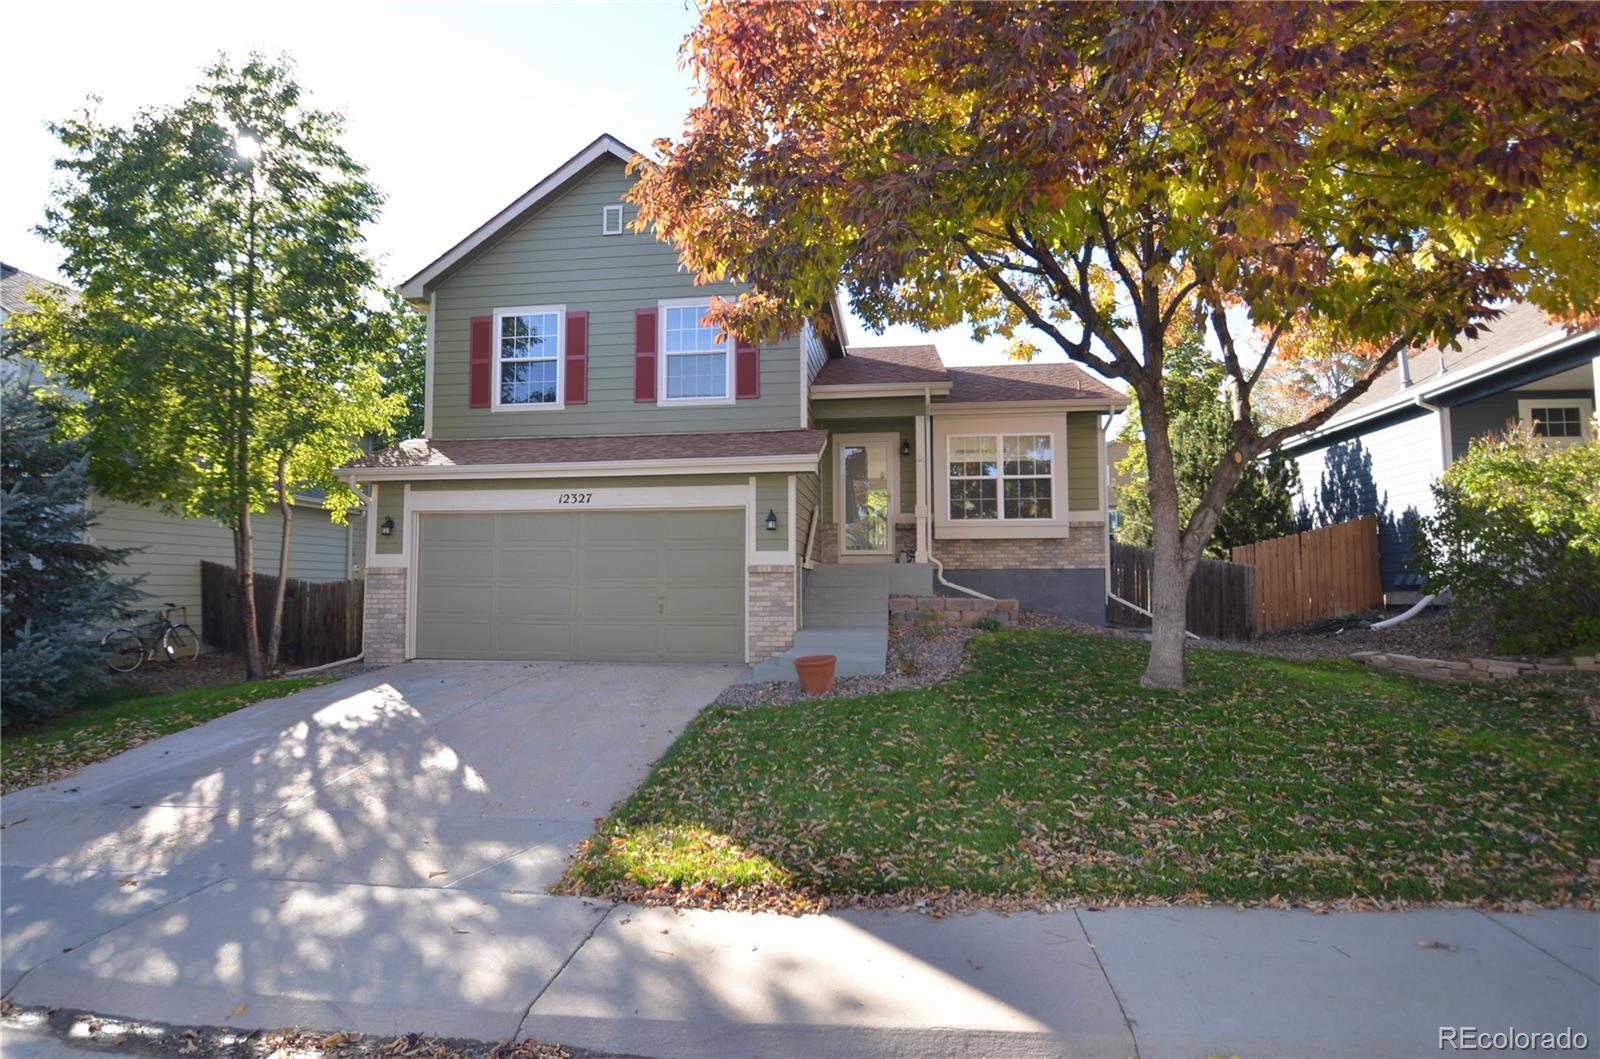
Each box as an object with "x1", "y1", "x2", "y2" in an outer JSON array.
[{"x1": 0, "y1": 264, "x2": 366, "y2": 629}]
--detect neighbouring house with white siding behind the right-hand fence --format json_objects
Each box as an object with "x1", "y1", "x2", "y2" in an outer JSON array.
[{"x1": 1286, "y1": 304, "x2": 1600, "y2": 593}]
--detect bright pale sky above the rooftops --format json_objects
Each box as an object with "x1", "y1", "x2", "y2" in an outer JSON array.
[{"x1": 0, "y1": 0, "x2": 1094, "y2": 371}]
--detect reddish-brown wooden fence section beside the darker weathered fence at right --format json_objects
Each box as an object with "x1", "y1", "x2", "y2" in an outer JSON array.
[{"x1": 1234, "y1": 515, "x2": 1384, "y2": 632}]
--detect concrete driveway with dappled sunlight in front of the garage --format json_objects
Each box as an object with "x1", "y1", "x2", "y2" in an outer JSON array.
[{"x1": 0, "y1": 662, "x2": 742, "y2": 1029}]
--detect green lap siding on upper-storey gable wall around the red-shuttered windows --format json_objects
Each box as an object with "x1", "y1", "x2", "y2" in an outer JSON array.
[{"x1": 434, "y1": 160, "x2": 803, "y2": 438}]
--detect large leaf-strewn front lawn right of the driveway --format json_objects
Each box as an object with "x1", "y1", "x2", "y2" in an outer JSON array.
[{"x1": 563, "y1": 632, "x2": 1600, "y2": 907}]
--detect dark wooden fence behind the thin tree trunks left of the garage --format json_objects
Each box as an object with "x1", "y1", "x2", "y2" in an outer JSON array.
[{"x1": 200, "y1": 561, "x2": 363, "y2": 665}]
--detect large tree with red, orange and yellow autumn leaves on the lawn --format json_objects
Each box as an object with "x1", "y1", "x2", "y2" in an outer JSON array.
[{"x1": 630, "y1": 0, "x2": 1600, "y2": 686}]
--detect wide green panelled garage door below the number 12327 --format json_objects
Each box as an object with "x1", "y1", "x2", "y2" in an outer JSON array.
[{"x1": 416, "y1": 512, "x2": 744, "y2": 662}]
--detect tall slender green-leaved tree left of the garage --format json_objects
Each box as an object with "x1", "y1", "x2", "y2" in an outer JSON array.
[{"x1": 18, "y1": 56, "x2": 394, "y2": 677}]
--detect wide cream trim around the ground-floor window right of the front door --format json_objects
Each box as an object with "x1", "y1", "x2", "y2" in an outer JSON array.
[{"x1": 930, "y1": 413, "x2": 1068, "y2": 541}]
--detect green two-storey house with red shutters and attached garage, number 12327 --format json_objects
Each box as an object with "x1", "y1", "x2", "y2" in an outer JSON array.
[{"x1": 344, "y1": 136, "x2": 1126, "y2": 662}]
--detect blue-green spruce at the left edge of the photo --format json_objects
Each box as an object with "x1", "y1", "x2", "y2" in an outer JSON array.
[{"x1": 0, "y1": 371, "x2": 139, "y2": 725}]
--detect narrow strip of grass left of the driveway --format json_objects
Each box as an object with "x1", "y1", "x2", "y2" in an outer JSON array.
[{"x1": 0, "y1": 677, "x2": 333, "y2": 790}]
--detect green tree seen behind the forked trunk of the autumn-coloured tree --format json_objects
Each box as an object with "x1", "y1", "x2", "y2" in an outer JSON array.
[{"x1": 1117, "y1": 325, "x2": 1299, "y2": 558}]
